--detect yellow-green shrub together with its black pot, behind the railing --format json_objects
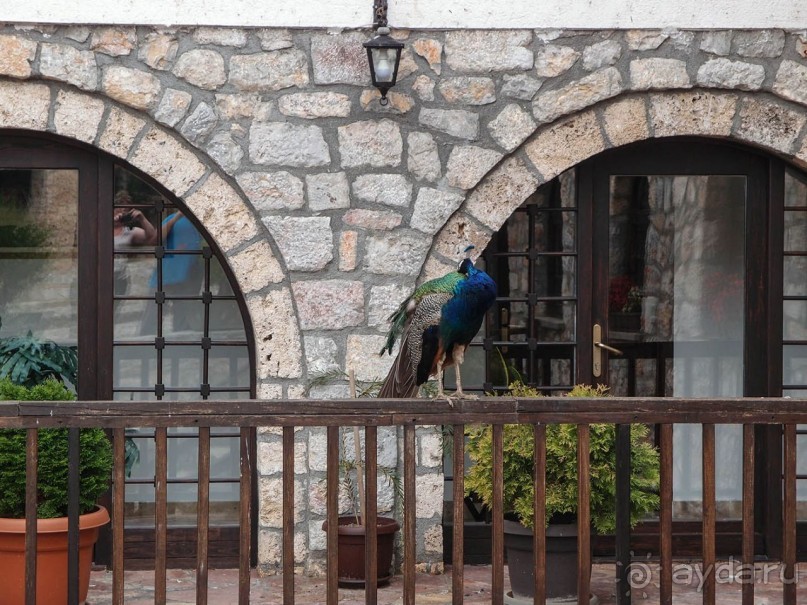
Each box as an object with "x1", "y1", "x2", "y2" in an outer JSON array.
[{"x1": 465, "y1": 383, "x2": 659, "y2": 602}]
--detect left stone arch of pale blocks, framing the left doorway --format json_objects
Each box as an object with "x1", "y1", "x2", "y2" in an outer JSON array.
[{"x1": 0, "y1": 80, "x2": 302, "y2": 386}]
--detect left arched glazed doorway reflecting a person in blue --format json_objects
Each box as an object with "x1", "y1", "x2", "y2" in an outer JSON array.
[{"x1": 0, "y1": 131, "x2": 255, "y2": 567}]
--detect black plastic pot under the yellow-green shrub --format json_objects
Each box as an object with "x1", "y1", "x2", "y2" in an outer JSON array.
[{"x1": 504, "y1": 521, "x2": 577, "y2": 602}]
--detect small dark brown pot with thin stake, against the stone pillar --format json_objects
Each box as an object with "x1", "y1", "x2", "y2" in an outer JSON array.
[{"x1": 322, "y1": 516, "x2": 400, "y2": 588}]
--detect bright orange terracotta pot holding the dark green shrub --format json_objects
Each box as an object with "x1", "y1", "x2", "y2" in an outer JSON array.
[{"x1": 0, "y1": 506, "x2": 109, "y2": 605}]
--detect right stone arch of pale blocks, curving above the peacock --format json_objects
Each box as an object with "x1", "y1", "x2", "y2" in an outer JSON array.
[{"x1": 430, "y1": 89, "x2": 807, "y2": 279}]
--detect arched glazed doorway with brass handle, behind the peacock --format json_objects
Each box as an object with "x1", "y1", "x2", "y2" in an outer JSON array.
[{"x1": 446, "y1": 138, "x2": 807, "y2": 557}]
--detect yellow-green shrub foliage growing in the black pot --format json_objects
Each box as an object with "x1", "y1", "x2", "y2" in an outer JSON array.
[{"x1": 465, "y1": 382, "x2": 659, "y2": 534}]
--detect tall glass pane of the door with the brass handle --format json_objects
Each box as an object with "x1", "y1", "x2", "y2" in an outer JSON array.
[{"x1": 608, "y1": 176, "x2": 746, "y2": 518}]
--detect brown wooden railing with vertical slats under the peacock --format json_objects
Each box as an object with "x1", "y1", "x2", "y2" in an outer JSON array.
[{"x1": 0, "y1": 397, "x2": 807, "y2": 605}]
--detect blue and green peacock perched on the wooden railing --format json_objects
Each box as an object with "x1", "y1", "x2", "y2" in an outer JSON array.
[{"x1": 378, "y1": 246, "x2": 496, "y2": 403}]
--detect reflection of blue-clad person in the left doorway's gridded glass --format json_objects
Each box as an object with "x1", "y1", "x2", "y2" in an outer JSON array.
[{"x1": 141, "y1": 211, "x2": 204, "y2": 333}]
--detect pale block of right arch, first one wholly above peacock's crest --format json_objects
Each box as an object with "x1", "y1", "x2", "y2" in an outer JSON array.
[{"x1": 465, "y1": 155, "x2": 540, "y2": 230}]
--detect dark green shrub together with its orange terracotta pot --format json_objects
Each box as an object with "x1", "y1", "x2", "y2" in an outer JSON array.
[{"x1": 0, "y1": 378, "x2": 112, "y2": 605}]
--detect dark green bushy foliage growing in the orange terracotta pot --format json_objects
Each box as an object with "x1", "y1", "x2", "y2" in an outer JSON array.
[{"x1": 0, "y1": 378, "x2": 112, "y2": 519}]
